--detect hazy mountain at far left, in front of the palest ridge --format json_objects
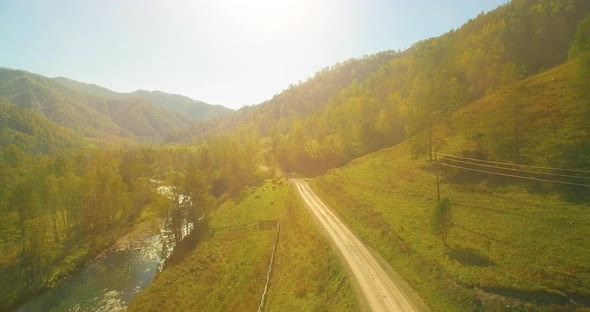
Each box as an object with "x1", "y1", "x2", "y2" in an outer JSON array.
[{"x1": 0, "y1": 69, "x2": 218, "y2": 142}]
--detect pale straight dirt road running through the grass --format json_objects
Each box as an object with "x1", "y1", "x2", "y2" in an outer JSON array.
[{"x1": 292, "y1": 179, "x2": 428, "y2": 311}]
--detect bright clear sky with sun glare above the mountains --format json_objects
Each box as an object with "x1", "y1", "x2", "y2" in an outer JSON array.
[{"x1": 0, "y1": 0, "x2": 507, "y2": 108}]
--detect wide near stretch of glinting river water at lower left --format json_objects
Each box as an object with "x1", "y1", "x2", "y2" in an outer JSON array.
[{"x1": 18, "y1": 235, "x2": 166, "y2": 312}]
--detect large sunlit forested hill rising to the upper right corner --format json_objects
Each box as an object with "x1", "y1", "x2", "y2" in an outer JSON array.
[{"x1": 168, "y1": 0, "x2": 590, "y2": 176}]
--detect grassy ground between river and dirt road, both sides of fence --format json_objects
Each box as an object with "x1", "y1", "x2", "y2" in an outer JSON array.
[{"x1": 129, "y1": 179, "x2": 359, "y2": 311}]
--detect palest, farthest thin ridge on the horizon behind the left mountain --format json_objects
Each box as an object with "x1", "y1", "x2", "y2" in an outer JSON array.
[{"x1": 52, "y1": 77, "x2": 233, "y2": 121}]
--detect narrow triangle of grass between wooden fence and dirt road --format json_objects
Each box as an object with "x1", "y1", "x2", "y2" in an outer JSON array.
[{"x1": 266, "y1": 182, "x2": 359, "y2": 311}]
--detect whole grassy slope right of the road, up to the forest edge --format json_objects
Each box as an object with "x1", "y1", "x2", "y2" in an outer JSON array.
[{"x1": 312, "y1": 60, "x2": 590, "y2": 311}]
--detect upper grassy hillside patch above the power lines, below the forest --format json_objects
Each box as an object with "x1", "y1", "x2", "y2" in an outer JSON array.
[{"x1": 454, "y1": 60, "x2": 583, "y2": 167}]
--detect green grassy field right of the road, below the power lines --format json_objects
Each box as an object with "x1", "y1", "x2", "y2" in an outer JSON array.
[{"x1": 312, "y1": 144, "x2": 590, "y2": 311}]
